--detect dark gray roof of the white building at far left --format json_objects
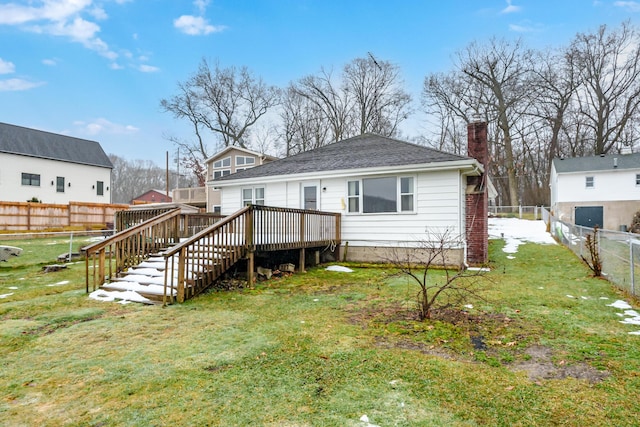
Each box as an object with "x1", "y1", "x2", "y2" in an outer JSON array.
[{"x1": 0, "y1": 123, "x2": 113, "y2": 168}]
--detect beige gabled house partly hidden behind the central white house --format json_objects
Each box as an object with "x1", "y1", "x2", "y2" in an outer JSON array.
[{"x1": 202, "y1": 146, "x2": 277, "y2": 213}]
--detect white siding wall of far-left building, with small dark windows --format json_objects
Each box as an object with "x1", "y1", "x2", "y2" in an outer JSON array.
[{"x1": 0, "y1": 153, "x2": 111, "y2": 204}]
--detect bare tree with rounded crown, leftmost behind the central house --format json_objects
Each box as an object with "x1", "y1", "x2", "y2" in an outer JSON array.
[{"x1": 160, "y1": 59, "x2": 280, "y2": 161}]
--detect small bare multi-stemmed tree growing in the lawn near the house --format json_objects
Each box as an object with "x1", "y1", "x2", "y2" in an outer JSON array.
[{"x1": 391, "y1": 231, "x2": 484, "y2": 320}]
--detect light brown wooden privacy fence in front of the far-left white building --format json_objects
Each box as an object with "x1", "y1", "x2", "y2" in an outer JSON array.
[{"x1": 0, "y1": 202, "x2": 129, "y2": 231}]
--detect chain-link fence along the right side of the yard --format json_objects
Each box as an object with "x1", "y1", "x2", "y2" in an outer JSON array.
[{"x1": 542, "y1": 209, "x2": 640, "y2": 296}]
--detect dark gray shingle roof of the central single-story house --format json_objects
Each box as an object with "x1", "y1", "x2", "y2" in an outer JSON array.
[{"x1": 215, "y1": 134, "x2": 470, "y2": 181}]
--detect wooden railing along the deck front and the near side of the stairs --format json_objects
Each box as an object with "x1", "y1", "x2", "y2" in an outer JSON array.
[{"x1": 163, "y1": 205, "x2": 341, "y2": 304}]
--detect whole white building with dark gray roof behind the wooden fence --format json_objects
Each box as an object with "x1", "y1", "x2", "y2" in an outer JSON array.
[{"x1": 0, "y1": 123, "x2": 113, "y2": 204}]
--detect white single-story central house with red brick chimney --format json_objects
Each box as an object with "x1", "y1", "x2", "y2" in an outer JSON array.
[{"x1": 208, "y1": 123, "x2": 488, "y2": 265}]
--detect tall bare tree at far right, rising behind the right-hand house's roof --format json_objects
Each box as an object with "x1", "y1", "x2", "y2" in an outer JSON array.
[{"x1": 567, "y1": 22, "x2": 640, "y2": 155}]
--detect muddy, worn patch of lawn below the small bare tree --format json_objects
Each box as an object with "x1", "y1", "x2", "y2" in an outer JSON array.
[{"x1": 349, "y1": 301, "x2": 610, "y2": 383}]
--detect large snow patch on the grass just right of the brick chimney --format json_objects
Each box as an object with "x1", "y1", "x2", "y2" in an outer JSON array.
[{"x1": 489, "y1": 218, "x2": 558, "y2": 254}]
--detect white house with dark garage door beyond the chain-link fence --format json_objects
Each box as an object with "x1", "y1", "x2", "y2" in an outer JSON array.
[{"x1": 549, "y1": 153, "x2": 640, "y2": 230}]
